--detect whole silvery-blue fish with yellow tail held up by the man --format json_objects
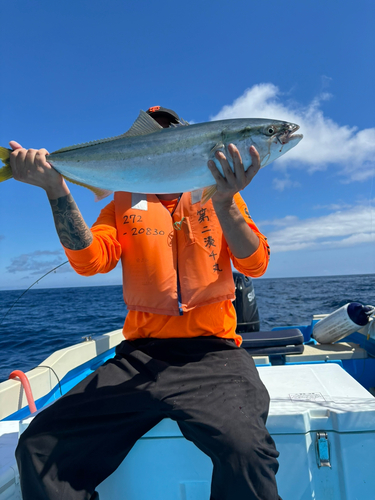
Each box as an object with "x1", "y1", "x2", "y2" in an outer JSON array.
[{"x1": 0, "y1": 110, "x2": 303, "y2": 204}]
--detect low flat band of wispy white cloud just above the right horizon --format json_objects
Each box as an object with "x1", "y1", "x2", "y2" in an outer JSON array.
[{"x1": 259, "y1": 201, "x2": 375, "y2": 253}]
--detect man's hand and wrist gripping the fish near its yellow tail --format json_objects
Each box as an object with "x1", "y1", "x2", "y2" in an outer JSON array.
[{"x1": 9, "y1": 141, "x2": 69, "y2": 199}]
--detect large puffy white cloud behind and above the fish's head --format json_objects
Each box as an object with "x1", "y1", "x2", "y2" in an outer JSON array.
[{"x1": 212, "y1": 83, "x2": 375, "y2": 187}]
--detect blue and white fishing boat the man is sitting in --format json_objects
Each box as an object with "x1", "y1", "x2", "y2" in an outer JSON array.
[{"x1": 0, "y1": 276, "x2": 375, "y2": 500}]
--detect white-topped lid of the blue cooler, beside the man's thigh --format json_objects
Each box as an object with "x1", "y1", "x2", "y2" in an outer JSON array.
[{"x1": 257, "y1": 360, "x2": 375, "y2": 434}]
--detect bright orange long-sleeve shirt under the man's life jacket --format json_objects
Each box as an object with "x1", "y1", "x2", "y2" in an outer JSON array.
[{"x1": 65, "y1": 195, "x2": 269, "y2": 345}]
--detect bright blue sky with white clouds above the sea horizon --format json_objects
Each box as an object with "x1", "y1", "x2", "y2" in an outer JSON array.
[{"x1": 0, "y1": 0, "x2": 375, "y2": 290}]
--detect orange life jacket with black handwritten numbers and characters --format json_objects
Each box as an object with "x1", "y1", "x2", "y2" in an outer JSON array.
[{"x1": 114, "y1": 192, "x2": 235, "y2": 316}]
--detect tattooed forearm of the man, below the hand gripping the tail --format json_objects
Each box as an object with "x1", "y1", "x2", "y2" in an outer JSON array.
[{"x1": 49, "y1": 194, "x2": 93, "y2": 250}]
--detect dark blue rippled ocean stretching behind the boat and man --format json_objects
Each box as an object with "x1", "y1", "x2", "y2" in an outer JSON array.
[{"x1": 0, "y1": 274, "x2": 375, "y2": 382}]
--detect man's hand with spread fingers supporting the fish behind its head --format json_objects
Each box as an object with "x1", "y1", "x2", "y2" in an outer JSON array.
[{"x1": 208, "y1": 144, "x2": 260, "y2": 206}]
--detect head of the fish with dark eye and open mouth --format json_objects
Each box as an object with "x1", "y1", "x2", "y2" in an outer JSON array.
[{"x1": 223, "y1": 119, "x2": 303, "y2": 168}]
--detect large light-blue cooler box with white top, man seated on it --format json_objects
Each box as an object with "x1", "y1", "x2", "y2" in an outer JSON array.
[{"x1": 94, "y1": 363, "x2": 375, "y2": 500}]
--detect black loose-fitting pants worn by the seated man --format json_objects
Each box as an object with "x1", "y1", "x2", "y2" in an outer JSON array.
[{"x1": 16, "y1": 337, "x2": 280, "y2": 500}]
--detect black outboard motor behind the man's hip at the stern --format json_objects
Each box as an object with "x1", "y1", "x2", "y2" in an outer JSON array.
[{"x1": 233, "y1": 272, "x2": 260, "y2": 334}]
